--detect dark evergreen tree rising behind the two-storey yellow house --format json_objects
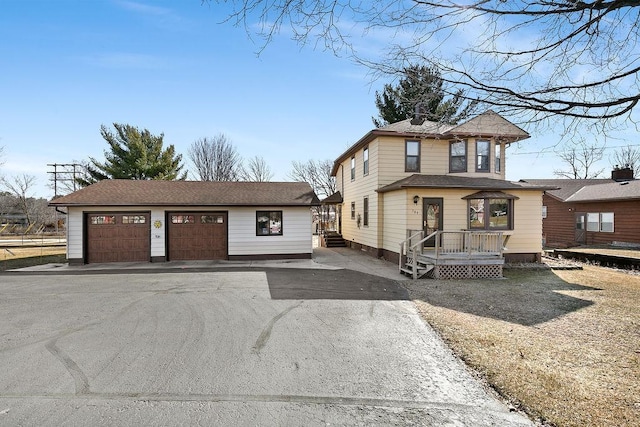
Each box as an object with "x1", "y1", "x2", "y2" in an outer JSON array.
[{"x1": 372, "y1": 65, "x2": 476, "y2": 127}]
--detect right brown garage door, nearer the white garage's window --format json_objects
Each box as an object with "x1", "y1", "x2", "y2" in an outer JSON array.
[{"x1": 167, "y1": 212, "x2": 227, "y2": 261}]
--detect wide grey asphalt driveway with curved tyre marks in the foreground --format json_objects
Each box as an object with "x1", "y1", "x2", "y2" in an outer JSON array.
[{"x1": 0, "y1": 268, "x2": 531, "y2": 426}]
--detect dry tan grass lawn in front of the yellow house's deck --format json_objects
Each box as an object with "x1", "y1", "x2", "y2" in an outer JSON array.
[{"x1": 405, "y1": 267, "x2": 640, "y2": 426}]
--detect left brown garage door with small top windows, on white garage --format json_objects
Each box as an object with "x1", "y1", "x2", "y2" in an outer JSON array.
[{"x1": 86, "y1": 212, "x2": 151, "y2": 263}]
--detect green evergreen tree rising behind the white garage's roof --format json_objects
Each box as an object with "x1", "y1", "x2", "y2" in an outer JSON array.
[{"x1": 77, "y1": 123, "x2": 187, "y2": 186}]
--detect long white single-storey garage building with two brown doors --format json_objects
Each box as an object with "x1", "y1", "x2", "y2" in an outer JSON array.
[{"x1": 50, "y1": 179, "x2": 318, "y2": 264}]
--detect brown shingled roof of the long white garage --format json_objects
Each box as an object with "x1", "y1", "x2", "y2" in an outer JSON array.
[{"x1": 49, "y1": 179, "x2": 319, "y2": 206}]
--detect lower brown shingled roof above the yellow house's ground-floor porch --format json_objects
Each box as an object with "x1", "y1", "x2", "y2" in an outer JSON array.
[{"x1": 377, "y1": 174, "x2": 555, "y2": 193}]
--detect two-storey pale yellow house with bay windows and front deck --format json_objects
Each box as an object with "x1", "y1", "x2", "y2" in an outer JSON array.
[{"x1": 323, "y1": 111, "x2": 544, "y2": 277}]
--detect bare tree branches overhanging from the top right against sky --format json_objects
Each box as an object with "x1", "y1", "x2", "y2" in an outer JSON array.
[{"x1": 212, "y1": 0, "x2": 640, "y2": 123}]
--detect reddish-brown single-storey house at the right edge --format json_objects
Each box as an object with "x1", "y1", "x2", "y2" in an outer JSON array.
[{"x1": 523, "y1": 168, "x2": 640, "y2": 248}]
